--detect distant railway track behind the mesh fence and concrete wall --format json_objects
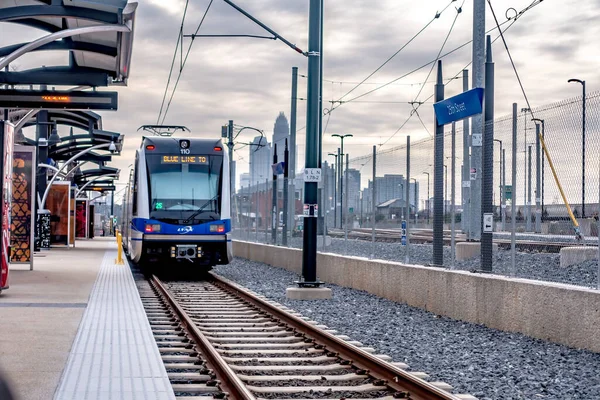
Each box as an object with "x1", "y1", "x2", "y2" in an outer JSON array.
[{"x1": 328, "y1": 228, "x2": 581, "y2": 253}]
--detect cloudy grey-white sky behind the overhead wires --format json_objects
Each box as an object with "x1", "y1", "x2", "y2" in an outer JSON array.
[{"x1": 0, "y1": 0, "x2": 600, "y2": 205}]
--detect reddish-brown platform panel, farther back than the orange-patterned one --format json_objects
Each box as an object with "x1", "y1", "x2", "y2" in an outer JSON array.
[{"x1": 46, "y1": 182, "x2": 71, "y2": 246}]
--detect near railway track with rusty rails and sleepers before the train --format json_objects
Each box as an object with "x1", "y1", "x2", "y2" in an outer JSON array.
[{"x1": 138, "y1": 275, "x2": 475, "y2": 400}]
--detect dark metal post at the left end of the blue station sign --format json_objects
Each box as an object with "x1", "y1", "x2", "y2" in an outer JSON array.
[{"x1": 433, "y1": 60, "x2": 444, "y2": 267}]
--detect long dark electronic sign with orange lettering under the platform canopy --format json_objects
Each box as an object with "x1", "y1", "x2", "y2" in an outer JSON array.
[{"x1": 0, "y1": 89, "x2": 119, "y2": 110}]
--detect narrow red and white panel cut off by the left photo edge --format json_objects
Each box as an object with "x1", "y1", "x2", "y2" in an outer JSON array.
[{"x1": 0, "y1": 121, "x2": 14, "y2": 290}]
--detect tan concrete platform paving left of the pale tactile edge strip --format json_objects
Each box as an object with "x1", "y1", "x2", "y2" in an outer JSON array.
[{"x1": 0, "y1": 238, "x2": 107, "y2": 400}]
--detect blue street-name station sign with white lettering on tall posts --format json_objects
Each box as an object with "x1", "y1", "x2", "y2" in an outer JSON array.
[{"x1": 433, "y1": 88, "x2": 483, "y2": 125}]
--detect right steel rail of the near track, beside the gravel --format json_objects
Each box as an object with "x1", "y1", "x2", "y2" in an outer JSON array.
[{"x1": 210, "y1": 273, "x2": 459, "y2": 400}]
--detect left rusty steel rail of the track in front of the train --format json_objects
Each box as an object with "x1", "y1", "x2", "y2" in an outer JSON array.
[{"x1": 150, "y1": 275, "x2": 256, "y2": 400}]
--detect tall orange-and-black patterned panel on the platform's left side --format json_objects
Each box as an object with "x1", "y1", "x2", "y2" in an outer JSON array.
[{"x1": 10, "y1": 145, "x2": 36, "y2": 269}]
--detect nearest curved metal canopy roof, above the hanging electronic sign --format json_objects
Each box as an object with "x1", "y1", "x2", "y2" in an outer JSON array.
[{"x1": 0, "y1": 0, "x2": 137, "y2": 87}]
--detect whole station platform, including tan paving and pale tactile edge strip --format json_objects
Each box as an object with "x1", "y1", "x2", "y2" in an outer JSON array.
[{"x1": 0, "y1": 238, "x2": 174, "y2": 400}]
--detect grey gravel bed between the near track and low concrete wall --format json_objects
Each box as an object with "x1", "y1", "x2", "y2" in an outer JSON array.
[{"x1": 215, "y1": 260, "x2": 600, "y2": 400}]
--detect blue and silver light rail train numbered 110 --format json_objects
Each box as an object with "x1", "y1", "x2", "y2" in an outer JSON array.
[{"x1": 123, "y1": 136, "x2": 232, "y2": 270}]
